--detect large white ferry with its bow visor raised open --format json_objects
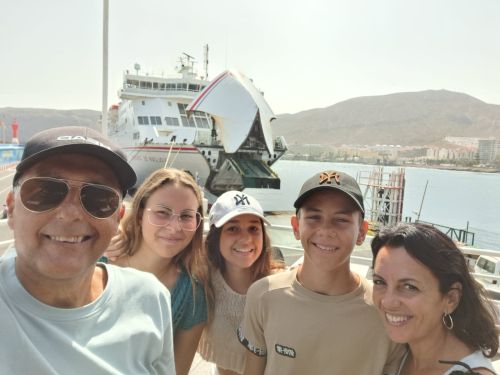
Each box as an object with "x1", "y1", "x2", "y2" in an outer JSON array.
[{"x1": 108, "y1": 54, "x2": 287, "y2": 200}]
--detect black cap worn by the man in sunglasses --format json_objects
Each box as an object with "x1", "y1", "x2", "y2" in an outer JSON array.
[{"x1": 13, "y1": 126, "x2": 137, "y2": 196}]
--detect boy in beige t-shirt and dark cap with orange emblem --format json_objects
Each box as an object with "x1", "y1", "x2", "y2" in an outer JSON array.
[{"x1": 238, "y1": 171, "x2": 400, "y2": 375}]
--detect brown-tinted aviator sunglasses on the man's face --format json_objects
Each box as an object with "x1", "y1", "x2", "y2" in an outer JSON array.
[{"x1": 17, "y1": 177, "x2": 121, "y2": 219}]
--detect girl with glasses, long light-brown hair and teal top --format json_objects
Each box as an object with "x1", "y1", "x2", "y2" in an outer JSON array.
[{"x1": 107, "y1": 169, "x2": 207, "y2": 375}]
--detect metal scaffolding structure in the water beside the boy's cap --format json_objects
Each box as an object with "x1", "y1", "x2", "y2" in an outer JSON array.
[{"x1": 358, "y1": 167, "x2": 405, "y2": 231}]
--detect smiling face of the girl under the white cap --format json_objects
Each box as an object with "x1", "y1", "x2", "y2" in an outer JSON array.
[{"x1": 219, "y1": 214, "x2": 264, "y2": 269}]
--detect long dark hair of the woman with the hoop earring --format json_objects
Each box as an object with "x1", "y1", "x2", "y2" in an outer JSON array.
[{"x1": 371, "y1": 223, "x2": 498, "y2": 358}]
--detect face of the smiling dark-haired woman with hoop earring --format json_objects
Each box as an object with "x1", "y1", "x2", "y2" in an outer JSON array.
[{"x1": 373, "y1": 246, "x2": 458, "y2": 345}]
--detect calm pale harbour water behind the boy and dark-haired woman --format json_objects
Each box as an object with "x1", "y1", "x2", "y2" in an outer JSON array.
[{"x1": 246, "y1": 160, "x2": 500, "y2": 251}]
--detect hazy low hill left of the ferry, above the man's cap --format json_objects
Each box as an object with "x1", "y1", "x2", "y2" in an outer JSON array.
[{"x1": 0, "y1": 107, "x2": 101, "y2": 143}]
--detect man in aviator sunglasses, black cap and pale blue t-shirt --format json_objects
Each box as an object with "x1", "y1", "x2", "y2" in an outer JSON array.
[{"x1": 0, "y1": 127, "x2": 175, "y2": 374}]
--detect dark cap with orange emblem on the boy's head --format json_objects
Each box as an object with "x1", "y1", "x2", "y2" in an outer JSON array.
[{"x1": 293, "y1": 171, "x2": 365, "y2": 217}]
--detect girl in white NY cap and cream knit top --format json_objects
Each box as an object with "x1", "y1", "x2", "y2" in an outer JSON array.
[{"x1": 198, "y1": 191, "x2": 283, "y2": 375}]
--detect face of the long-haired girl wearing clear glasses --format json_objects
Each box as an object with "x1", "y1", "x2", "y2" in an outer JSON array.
[{"x1": 141, "y1": 183, "x2": 198, "y2": 258}]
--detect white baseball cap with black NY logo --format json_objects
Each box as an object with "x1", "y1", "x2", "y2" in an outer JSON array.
[{"x1": 208, "y1": 190, "x2": 270, "y2": 228}]
